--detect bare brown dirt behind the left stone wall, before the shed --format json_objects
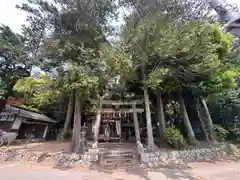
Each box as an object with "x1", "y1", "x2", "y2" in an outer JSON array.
[{"x1": 0, "y1": 141, "x2": 70, "y2": 153}]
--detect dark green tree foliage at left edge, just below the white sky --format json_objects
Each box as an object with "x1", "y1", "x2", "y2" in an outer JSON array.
[{"x1": 0, "y1": 25, "x2": 32, "y2": 97}]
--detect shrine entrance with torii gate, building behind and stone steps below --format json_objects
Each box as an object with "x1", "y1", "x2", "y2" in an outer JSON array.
[{"x1": 83, "y1": 100, "x2": 150, "y2": 165}]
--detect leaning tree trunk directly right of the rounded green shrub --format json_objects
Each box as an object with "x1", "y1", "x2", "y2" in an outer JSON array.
[{"x1": 178, "y1": 93, "x2": 196, "y2": 143}]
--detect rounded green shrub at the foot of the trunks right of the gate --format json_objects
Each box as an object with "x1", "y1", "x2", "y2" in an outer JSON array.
[{"x1": 166, "y1": 126, "x2": 187, "y2": 149}]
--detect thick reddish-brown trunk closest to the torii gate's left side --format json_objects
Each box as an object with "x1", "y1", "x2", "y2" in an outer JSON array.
[{"x1": 72, "y1": 92, "x2": 81, "y2": 153}]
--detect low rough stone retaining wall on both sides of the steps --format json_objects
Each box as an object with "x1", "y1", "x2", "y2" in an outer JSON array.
[{"x1": 0, "y1": 147, "x2": 232, "y2": 168}]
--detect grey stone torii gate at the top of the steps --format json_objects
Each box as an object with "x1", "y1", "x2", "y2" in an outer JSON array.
[{"x1": 93, "y1": 100, "x2": 144, "y2": 148}]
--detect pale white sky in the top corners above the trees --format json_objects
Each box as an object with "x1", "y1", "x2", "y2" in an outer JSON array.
[{"x1": 0, "y1": 0, "x2": 240, "y2": 33}]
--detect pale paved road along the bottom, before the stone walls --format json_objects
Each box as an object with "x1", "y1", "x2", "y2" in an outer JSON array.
[{"x1": 0, "y1": 162, "x2": 240, "y2": 180}]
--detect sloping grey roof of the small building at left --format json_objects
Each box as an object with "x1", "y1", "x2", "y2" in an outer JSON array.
[{"x1": 5, "y1": 105, "x2": 56, "y2": 123}]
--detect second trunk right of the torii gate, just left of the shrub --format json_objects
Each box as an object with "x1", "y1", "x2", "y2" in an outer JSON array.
[{"x1": 157, "y1": 92, "x2": 166, "y2": 139}]
